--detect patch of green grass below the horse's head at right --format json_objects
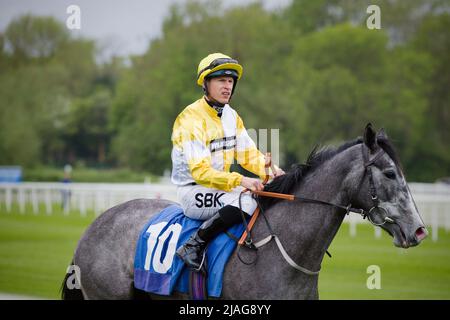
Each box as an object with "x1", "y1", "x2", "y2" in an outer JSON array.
[{"x1": 319, "y1": 224, "x2": 450, "y2": 300}]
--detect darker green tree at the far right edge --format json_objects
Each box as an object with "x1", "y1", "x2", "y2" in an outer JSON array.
[{"x1": 408, "y1": 13, "x2": 450, "y2": 181}]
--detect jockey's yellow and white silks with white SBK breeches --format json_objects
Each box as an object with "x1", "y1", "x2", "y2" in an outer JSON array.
[{"x1": 172, "y1": 98, "x2": 273, "y2": 219}]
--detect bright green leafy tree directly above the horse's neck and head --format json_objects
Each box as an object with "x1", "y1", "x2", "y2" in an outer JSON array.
[{"x1": 286, "y1": 24, "x2": 430, "y2": 178}]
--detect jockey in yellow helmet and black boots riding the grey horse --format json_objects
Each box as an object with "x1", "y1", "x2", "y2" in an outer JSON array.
[{"x1": 171, "y1": 53, "x2": 284, "y2": 271}]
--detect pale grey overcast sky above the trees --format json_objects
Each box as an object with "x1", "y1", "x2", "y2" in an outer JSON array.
[{"x1": 0, "y1": 0, "x2": 290, "y2": 56}]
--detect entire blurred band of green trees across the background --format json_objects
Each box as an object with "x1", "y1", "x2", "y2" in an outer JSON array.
[{"x1": 0, "y1": 0, "x2": 450, "y2": 181}]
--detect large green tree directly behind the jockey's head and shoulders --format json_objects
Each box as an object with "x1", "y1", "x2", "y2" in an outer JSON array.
[{"x1": 111, "y1": 2, "x2": 289, "y2": 173}]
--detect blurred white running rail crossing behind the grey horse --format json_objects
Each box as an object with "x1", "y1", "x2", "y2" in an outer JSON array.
[{"x1": 0, "y1": 182, "x2": 450, "y2": 241}]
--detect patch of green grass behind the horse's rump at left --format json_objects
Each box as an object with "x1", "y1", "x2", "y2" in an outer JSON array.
[{"x1": 0, "y1": 206, "x2": 94, "y2": 299}]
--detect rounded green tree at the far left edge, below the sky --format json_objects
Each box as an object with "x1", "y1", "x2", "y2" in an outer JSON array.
[{"x1": 0, "y1": 15, "x2": 97, "y2": 166}]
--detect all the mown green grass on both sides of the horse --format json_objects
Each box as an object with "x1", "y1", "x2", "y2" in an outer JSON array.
[{"x1": 0, "y1": 206, "x2": 450, "y2": 299}]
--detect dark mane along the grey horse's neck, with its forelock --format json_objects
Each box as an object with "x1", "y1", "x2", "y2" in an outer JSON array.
[{"x1": 258, "y1": 136, "x2": 401, "y2": 210}]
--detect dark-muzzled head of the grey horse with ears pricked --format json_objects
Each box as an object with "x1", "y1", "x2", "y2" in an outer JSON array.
[{"x1": 354, "y1": 124, "x2": 428, "y2": 248}]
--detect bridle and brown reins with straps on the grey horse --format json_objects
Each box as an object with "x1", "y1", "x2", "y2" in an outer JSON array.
[{"x1": 238, "y1": 143, "x2": 396, "y2": 275}]
